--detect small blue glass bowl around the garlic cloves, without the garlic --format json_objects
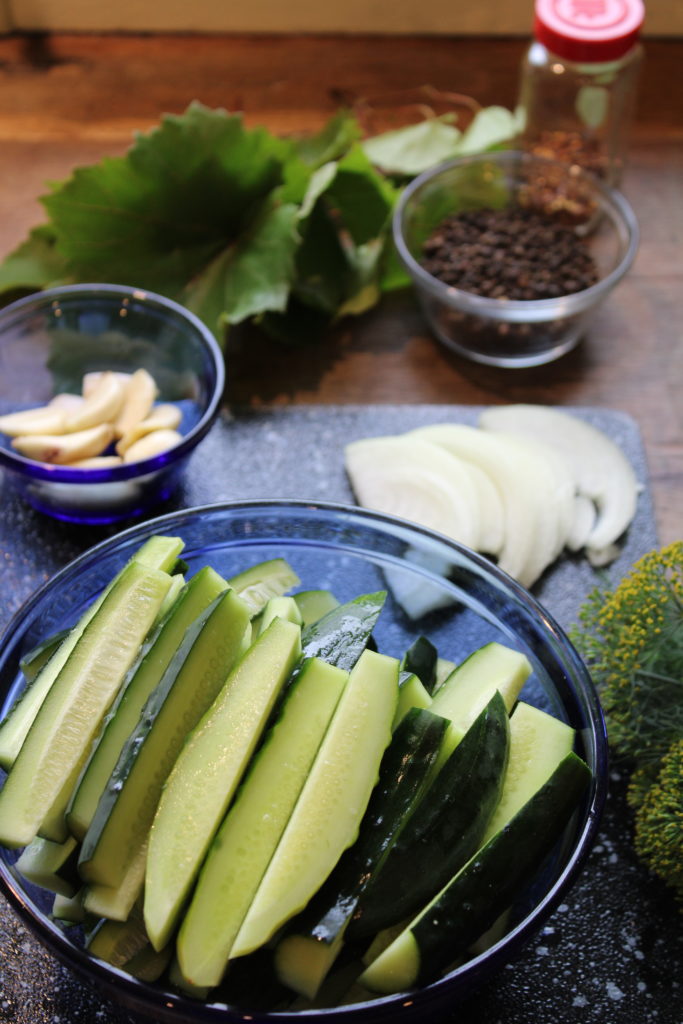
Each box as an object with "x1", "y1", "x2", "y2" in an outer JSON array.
[{"x1": 0, "y1": 285, "x2": 224, "y2": 523}]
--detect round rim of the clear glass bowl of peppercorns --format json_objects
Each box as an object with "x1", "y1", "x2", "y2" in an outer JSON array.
[{"x1": 392, "y1": 150, "x2": 640, "y2": 322}]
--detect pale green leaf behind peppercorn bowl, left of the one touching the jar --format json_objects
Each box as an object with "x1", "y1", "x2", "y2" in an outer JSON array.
[{"x1": 362, "y1": 118, "x2": 462, "y2": 177}]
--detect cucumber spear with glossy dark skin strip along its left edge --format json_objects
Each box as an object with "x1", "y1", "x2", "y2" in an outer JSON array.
[{"x1": 80, "y1": 590, "x2": 251, "y2": 888}]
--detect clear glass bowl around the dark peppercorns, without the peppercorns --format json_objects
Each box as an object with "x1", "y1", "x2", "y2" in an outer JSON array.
[{"x1": 393, "y1": 151, "x2": 638, "y2": 368}]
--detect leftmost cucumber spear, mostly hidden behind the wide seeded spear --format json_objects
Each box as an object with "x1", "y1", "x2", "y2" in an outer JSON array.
[{"x1": 0, "y1": 537, "x2": 183, "y2": 771}]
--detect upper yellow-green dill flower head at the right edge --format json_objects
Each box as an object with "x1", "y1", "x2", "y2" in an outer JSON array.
[{"x1": 572, "y1": 541, "x2": 683, "y2": 770}]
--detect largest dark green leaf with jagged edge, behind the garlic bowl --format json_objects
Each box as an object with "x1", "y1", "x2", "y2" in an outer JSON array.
[{"x1": 43, "y1": 103, "x2": 292, "y2": 297}]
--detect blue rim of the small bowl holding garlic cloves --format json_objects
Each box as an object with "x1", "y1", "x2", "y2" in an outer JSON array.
[{"x1": 0, "y1": 283, "x2": 225, "y2": 485}]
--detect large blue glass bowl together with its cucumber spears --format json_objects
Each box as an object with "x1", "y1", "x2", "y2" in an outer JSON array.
[{"x1": 0, "y1": 501, "x2": 607, "y2": 1024}]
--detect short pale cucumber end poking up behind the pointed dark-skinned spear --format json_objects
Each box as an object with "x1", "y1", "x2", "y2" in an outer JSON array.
[{"x1": 430, "y1": 642, "x2": 531, "y2": 733}]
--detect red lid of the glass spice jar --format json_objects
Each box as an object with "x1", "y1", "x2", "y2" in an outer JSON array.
[{"x1": 533, "y1": 0, "x2": 645, "y2": 63}]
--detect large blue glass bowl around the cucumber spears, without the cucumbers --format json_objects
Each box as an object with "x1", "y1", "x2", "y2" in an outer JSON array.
[{"x1": 0, "y1": 501, "x2": 607, "y2": 1024}]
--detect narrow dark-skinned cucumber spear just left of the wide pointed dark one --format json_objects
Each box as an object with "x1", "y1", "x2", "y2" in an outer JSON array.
[{"x1": 275, "y1": 708, "x2": 447, "y2": 999}]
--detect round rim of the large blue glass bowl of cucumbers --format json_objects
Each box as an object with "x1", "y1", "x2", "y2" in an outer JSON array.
[{"x1": 0, "y1": 498, "x2": 608, "y2": 1024}]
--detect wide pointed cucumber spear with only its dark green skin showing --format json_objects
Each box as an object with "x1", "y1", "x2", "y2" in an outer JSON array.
[{"x1": 347, "y1": 692, "x2": 510, "y2": 943}]
